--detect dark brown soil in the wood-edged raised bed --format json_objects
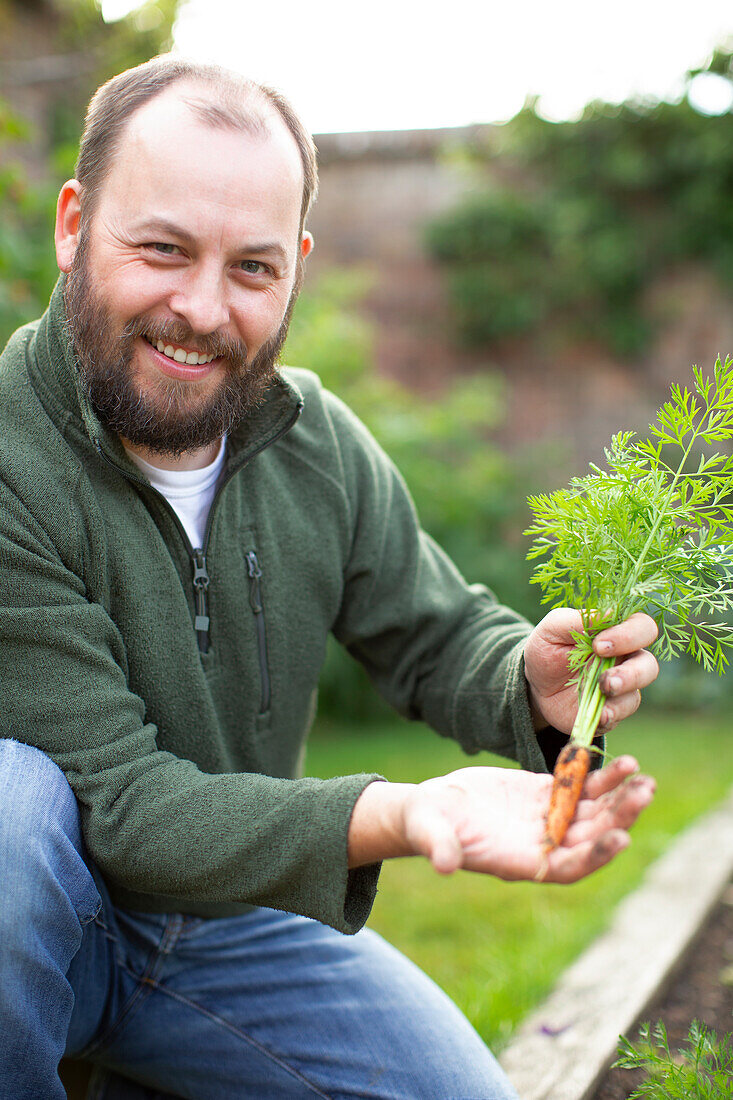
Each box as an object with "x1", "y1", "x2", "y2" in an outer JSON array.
[{"x1": 592, "y1": 886, "x2": 733, "y2": 1100}]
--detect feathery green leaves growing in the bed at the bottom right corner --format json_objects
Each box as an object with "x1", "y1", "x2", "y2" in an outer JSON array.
[{"x1": 614, "y1": 1020, "x2": 733, "y2": 1100}]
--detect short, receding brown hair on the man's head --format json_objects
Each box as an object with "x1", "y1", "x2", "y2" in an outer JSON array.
[{"x1": 75, "y1": 55, "x2": 318, "y2": 231}]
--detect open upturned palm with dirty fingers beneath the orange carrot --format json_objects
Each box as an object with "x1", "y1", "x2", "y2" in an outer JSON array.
[{"x1": 396, "y1": 756, "x2": 655, "y2": 882}]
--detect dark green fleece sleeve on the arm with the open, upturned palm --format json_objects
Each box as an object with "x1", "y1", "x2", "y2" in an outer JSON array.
[{"x1": 0, "y1": 484, "x2": 380, "y2": 933}]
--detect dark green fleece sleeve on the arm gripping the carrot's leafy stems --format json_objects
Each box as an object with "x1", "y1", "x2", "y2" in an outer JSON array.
[{"x1": 325, "y1": 394, "x2": 547, "y2": 771}]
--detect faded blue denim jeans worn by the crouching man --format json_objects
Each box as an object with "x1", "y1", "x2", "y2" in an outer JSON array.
[{"x1": 0, "y1": 740, "x2": 516, "y2": 1100}]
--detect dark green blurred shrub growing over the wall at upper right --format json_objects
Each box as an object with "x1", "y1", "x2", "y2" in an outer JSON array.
[{"x1": 426, "y1": 51, "x2": 733, "y2": 355}]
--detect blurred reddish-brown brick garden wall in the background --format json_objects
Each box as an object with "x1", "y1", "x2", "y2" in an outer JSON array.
[{"x1": 308, "y1": 127, "x2": 733, "y2": 469}]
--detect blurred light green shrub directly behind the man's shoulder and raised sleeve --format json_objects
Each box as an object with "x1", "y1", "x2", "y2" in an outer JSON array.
[{"x1": 283, "y1": 272, "x2": 538, "y2": 721}]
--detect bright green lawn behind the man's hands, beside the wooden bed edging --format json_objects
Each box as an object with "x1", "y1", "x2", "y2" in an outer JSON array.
[{"x1": 307, "y1": 713, "x2": 733, "y2": 1049}]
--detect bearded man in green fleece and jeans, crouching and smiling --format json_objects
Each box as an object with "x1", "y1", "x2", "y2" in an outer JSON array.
[{"x1": 0, "y1": 58, "x2": 656, "y2": 1100}]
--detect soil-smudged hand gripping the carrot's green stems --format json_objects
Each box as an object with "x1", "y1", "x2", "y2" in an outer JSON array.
[{"x1": 524, "y1": 607, "x2": 659, "y2": 734}]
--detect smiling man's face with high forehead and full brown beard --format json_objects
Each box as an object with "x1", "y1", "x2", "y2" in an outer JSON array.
[{"x1": 66, "y1": 86, "x2": 310, "y2": 454}]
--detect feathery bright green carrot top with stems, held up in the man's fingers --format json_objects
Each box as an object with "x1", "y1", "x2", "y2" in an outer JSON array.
[{"x1": 526, "y1": 358, "x2": 733, "y2": 850}]
